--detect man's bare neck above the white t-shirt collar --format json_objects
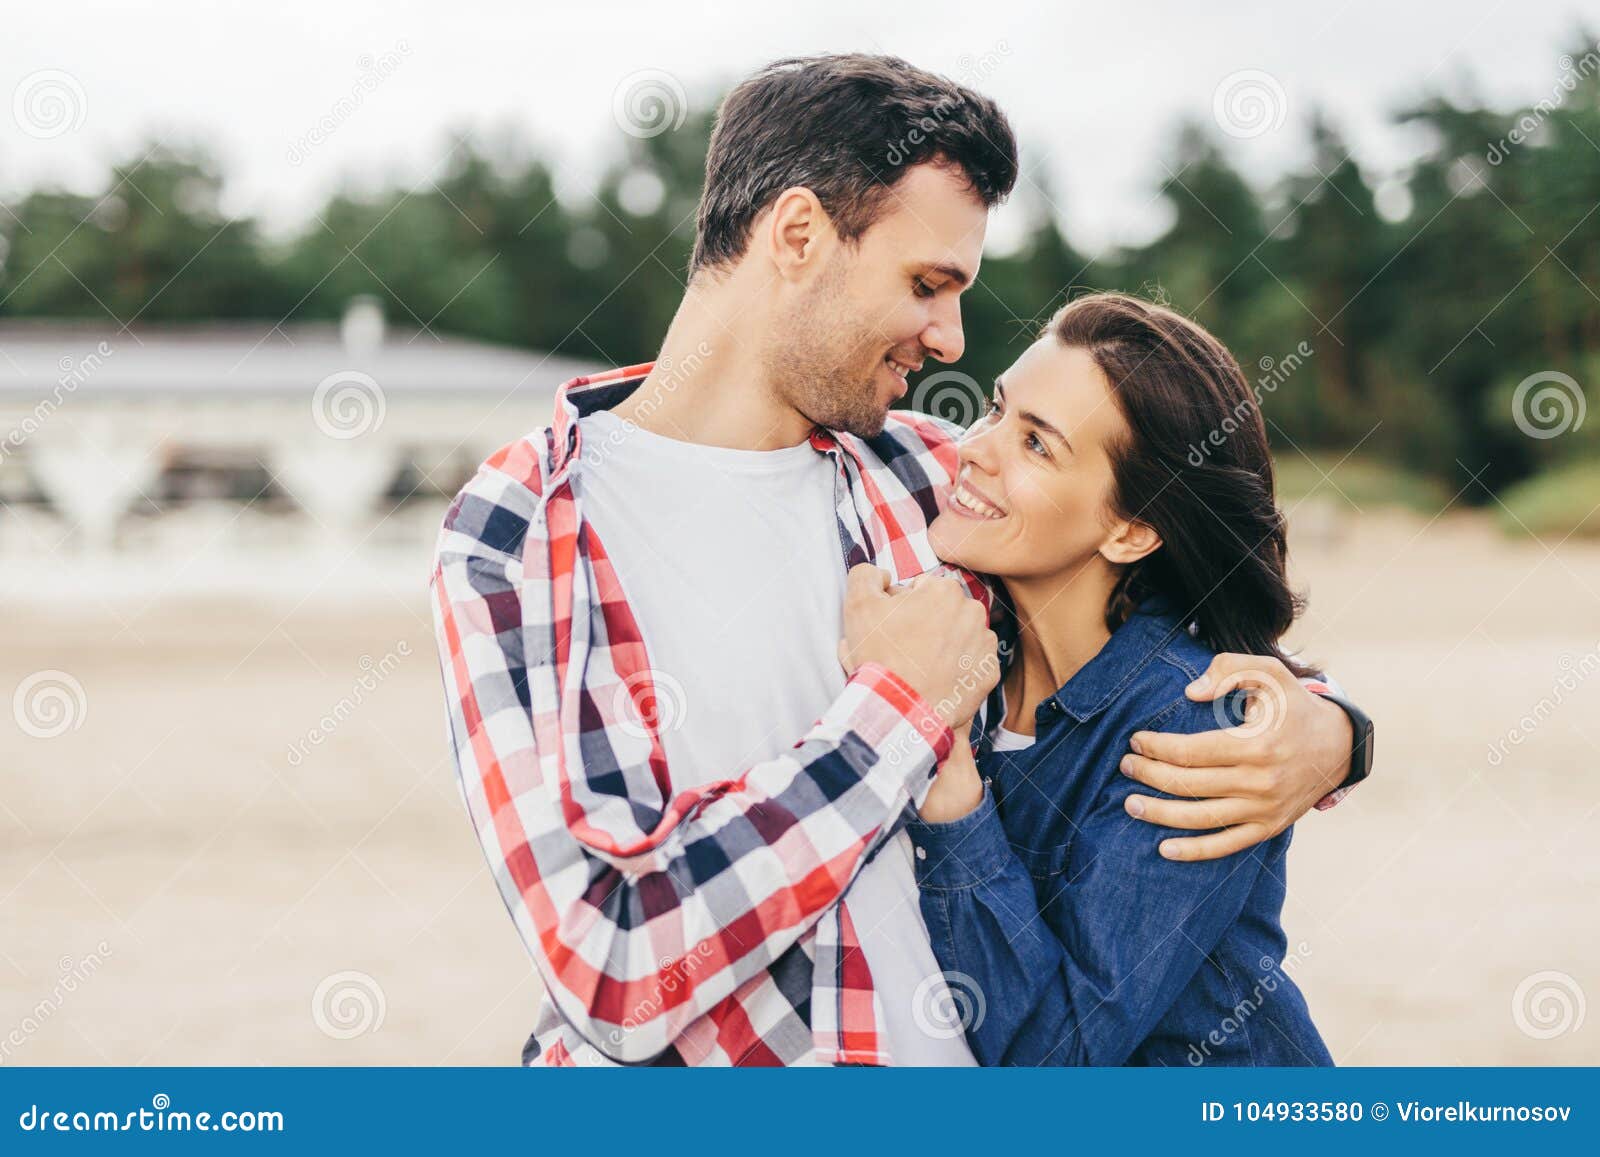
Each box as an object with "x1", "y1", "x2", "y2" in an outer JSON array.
[{"x1": 614, "y1": 272, "x2": 811, "y2": 450}]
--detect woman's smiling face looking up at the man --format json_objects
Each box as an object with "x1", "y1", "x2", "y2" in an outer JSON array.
[{"x1": 928, "y1": 334, "x2": 1128, "y2": 579}]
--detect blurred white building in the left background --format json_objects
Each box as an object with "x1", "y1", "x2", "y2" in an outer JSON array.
[{"x1": 0, "y1": 299, "x2": 595, "y2": 601}]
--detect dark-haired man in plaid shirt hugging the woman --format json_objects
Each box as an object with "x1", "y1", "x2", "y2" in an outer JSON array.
[{"x1": 432, "y1": 56, "x2": 1352, "y2": 1064}]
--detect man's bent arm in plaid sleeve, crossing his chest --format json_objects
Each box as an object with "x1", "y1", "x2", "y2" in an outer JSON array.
[{"x1": 432, "y1": 466, "x2": 992, "y2": 1063}]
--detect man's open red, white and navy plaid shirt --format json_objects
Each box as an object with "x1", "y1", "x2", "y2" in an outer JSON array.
[{"x1": 430, "y1": 363, "x2": 1356, "y2": 1064}]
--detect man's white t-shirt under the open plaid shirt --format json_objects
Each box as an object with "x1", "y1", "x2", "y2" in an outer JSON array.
[{"x1": 579, "y1": 411, "x2": 974, "y2": 1066}]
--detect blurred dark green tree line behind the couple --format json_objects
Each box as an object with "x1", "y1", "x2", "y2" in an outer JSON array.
[{"x1": 0, "y1": 35, "x2": 1600, "y2": 502}]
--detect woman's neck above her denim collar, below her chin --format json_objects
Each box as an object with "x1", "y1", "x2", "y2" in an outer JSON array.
[{"x1": 1005, "y1": 554, "x2": 1117, "y2": 735}]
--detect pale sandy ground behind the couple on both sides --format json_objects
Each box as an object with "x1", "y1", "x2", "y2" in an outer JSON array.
[{"x1": 0, "y1": 507, "x2": 1600, "y2": 1064}]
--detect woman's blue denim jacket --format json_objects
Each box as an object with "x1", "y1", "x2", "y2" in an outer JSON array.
[{"x1": 910, "y1": 603, "x2": 1333, "y2": 1066}]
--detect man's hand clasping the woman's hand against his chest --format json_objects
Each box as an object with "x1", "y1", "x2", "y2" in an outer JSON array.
[{"x1": 838, "y1": 563, "x2": 1000, "y2": 727}]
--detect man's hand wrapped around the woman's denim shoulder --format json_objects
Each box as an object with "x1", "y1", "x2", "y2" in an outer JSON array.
[{"x1": 1122, "y1": 655, "x2": 1354, "y2": 859}]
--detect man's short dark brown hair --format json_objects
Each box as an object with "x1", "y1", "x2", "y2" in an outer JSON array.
[{"x1": 690, "y1": 53, "x2": 1016, "y2": 277}]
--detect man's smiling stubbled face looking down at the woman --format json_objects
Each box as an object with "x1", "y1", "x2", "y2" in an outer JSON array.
[{"x1": 763, "y1": 163, "x2": 989, "y2": 437}]
